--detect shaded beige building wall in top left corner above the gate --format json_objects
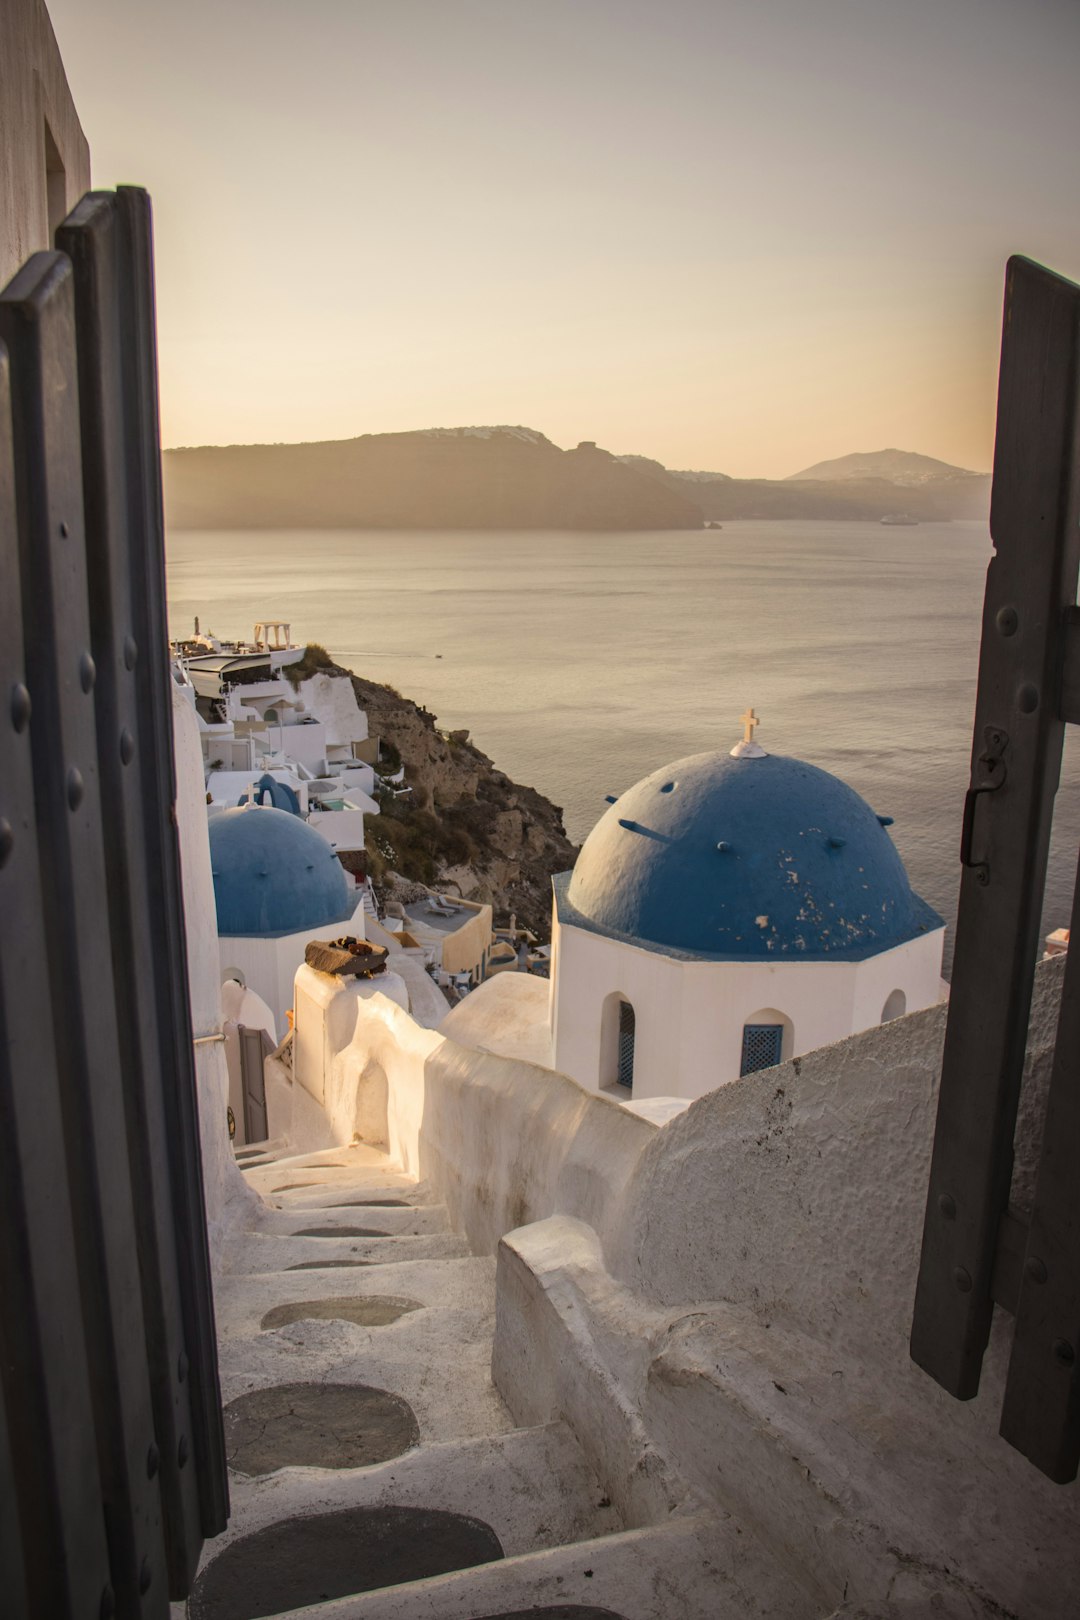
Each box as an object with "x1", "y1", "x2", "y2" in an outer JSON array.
[{"x1": 0, "y1": 0, "x2": 91, "y2": 287}]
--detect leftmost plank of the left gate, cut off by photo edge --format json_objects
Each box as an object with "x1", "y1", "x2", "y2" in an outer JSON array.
[{"x1": 0, "y1": 325, "x2": 112, "y2": 1617}]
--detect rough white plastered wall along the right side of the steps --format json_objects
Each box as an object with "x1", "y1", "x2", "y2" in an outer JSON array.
[{"x1": 283, "y1": 962, "x2": 1080, "y2": 1620}]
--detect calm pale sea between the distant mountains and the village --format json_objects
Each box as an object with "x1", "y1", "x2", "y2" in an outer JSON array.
[{"x1": 168, "y1": 522, "x2": 1080, "y2": 972}]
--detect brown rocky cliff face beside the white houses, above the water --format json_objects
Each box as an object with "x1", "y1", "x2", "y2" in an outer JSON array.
[{"x1": 293, "y1": 648, "x2": 578, "y2": 940}]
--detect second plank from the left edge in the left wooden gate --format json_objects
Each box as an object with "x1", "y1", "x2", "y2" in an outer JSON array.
[{"x1": 0, "y1": 253, "x2": 168, "y2": 1617}]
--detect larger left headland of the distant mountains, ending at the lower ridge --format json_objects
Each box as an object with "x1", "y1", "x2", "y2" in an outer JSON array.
[{"x1": 162, "y1": 426, "x2": 703, "y2": 530}]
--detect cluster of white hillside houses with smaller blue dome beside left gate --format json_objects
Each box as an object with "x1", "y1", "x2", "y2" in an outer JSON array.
[{"x1": 172, "y1": 620, "x2": 492, "y2": 1140}]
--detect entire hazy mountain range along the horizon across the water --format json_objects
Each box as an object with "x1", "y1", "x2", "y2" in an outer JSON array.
[{"x1": 164, "y1": 426, "x2": 989, "y2": 530}]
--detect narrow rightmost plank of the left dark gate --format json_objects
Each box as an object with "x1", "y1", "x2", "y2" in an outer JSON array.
[{"x1": 117, "y1": 186, "x2": 228, "y2": 1536}]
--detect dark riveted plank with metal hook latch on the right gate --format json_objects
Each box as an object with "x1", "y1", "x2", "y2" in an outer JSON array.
[{"x1": 912, "y1": 259, "x2": 1080, "y2": 1400}]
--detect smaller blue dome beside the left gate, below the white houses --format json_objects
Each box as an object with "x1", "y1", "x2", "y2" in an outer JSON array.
[{"x1": 209, "y1": 805, "x2": 353, "y2": 935}]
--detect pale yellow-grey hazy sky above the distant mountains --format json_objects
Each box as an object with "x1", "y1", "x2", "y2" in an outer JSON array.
[{"x1": 47, "y1": 0, "x2": 1080, "y2": 478}]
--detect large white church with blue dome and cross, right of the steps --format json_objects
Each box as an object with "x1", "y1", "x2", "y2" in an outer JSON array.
[{"x1": 551, "y1": 711, "x2": 944, "y2": 1102}]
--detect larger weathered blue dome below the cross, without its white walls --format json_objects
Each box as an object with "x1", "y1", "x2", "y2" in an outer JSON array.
[{"x1": 557, "y1": 753, "x2": 944, "y2": 961}]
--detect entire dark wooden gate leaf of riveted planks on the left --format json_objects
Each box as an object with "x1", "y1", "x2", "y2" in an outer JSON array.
[{"x1": 0, "y1": 190, "x2": 228, "y2": 1617}]
